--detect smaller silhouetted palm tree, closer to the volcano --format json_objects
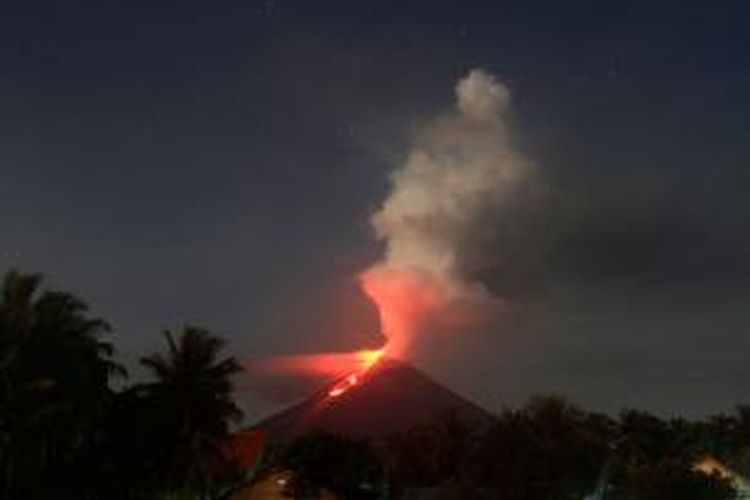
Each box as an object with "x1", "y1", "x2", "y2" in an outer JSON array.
[{"x1": 141, "y1": 327, "x2": 241, "y2": 493}]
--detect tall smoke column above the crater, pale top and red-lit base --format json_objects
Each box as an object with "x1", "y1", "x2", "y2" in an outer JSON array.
[{"x1": 360, "y1": 70, "x2": 534, "y2": 357}]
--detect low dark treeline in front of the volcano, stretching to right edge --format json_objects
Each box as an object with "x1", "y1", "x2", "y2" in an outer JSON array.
[{"x1": 275, "y1": 397, "x2": 750, "y2": 500}]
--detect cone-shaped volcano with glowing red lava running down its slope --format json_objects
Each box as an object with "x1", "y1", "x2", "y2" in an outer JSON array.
[{"x1": 255, "y1": 358, "x2": 493, "y2": 442}]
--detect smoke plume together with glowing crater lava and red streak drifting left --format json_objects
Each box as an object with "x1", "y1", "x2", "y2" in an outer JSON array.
[{"x1": 241, "y1": 70, "x2": 544, "y2": 399}]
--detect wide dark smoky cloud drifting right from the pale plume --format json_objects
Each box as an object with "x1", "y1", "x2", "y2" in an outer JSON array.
[{"x1": 476, "y1": 168, "x2": 750, "y2": 297}]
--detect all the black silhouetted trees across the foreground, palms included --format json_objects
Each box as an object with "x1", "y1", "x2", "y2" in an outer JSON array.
[{"x1": 0, "y1": 271, "x2": 750, "y2": 500}]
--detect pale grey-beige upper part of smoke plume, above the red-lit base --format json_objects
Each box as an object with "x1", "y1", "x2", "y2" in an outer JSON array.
[{"x1": 368, "y1": 70, "x2": 535, "y2": 300}]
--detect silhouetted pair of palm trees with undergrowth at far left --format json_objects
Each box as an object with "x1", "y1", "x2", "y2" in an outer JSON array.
[{"x1": 0, "y1": 271, "x2": 240, "y2": 500}]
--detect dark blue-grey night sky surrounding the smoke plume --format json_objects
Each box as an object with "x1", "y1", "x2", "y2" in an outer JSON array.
[{"x1": 0, "y1": 0, "x2": 750, "y2": 416}]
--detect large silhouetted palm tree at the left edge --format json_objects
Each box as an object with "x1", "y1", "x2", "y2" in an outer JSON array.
[{"x1": 0, "y1": 271, "x2": 124, "y2": 498}]
